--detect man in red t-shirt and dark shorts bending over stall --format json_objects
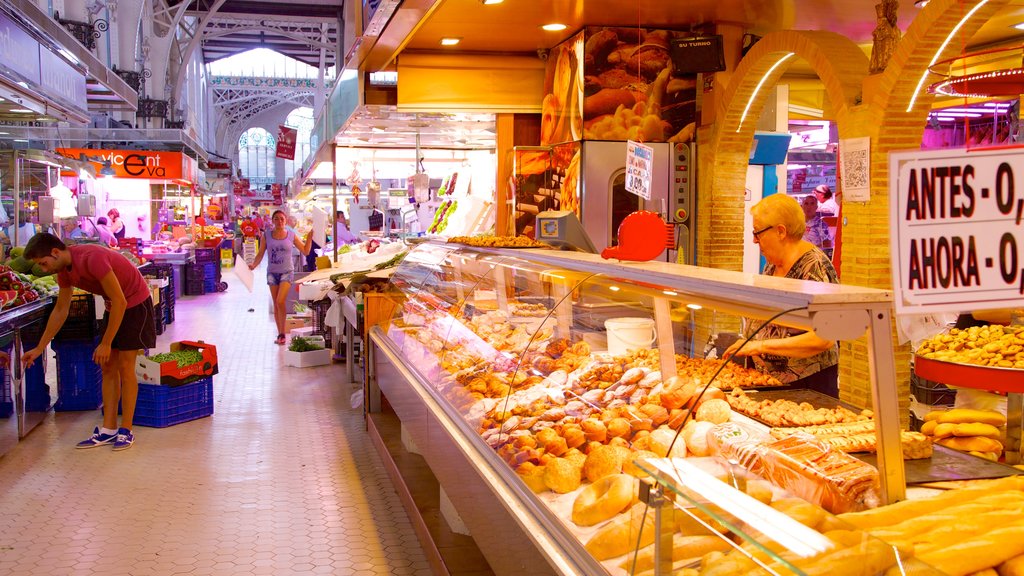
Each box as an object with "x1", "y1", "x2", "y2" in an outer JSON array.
[{"x1": 22, "y1": 234, "x2": 157, "y2": 450}]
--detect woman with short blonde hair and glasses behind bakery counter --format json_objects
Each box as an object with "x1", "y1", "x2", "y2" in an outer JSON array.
[{"x1": 724, "y1": 194, "x2": 839, "y2": 398}]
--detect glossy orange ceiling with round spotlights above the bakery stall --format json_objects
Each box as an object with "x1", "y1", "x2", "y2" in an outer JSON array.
[{"x1": 378, "y1": 0, "x2": 1024, "y2": 68}]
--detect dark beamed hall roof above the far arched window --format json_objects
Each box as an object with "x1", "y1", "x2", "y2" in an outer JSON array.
[{"x1": 168, "y1": 0, "x2": 344, "y2": 68}]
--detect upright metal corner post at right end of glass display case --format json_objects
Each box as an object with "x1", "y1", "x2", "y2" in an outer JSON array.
[{"x1": 867, "y1": 308, "x2": 906, "y2": 504}]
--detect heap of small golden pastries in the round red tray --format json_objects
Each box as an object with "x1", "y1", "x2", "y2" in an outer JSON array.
[{"x1": 918, "y1": 325, "x2": 1024, "y2": 369}]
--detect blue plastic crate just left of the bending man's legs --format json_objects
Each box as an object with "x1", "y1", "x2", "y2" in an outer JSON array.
[{"x1": 52, "y1": 338, "x2": 103, "y2": 412}]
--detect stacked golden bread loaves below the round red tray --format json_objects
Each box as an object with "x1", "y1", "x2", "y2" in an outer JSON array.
[{"x1": 921, "y1": 408, "x2": 1007, "y2": 462}]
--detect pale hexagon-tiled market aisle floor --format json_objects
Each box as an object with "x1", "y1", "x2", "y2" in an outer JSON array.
[{"x1": 0, "y1": 272, "x2": 430, "y2": 576}]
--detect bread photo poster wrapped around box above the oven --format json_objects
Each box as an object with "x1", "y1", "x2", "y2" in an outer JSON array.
[{"x1": 541, "y1": 27, "x2": 697, "y2": 145}]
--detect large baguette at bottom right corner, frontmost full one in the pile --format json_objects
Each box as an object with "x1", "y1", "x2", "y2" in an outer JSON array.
[{"x1": 918, "y1": 522, "x2": 1024, "y2": 576}]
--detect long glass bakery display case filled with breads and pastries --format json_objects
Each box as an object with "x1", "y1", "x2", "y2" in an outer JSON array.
[{"x1": 368, "y1": 243, "x2": 909, "y2": 575}]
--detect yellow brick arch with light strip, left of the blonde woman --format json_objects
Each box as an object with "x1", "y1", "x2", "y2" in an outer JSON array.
[{"x1": 697, "y1": 31, "x2": 868, "y2": 271}]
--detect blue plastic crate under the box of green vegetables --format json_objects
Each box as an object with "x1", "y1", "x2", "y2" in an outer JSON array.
[{"x1": 134, "y1": 377, "x2": 213, "y2": 428}]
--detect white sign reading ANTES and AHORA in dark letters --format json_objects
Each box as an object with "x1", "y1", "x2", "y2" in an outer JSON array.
[{"x1": 889, "y1": 145, "x2": 1024, "y2": 314}]
